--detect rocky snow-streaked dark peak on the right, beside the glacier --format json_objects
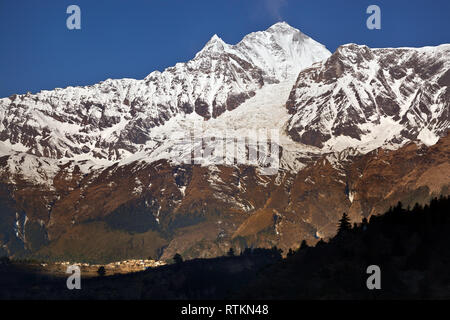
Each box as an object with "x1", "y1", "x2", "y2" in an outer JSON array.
[{"x1": 286, "y1": 44, "x2": 450, "y2": 149}]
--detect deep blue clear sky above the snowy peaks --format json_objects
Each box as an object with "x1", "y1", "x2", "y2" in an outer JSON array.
[{"x1": 0, "y1": 0, "x2": 450, "y2": 97}]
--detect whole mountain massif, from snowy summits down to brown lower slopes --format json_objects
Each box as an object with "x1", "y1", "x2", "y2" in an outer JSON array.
[{"x1": 0, "y1": 23, "x2": 450, "y2": 262}]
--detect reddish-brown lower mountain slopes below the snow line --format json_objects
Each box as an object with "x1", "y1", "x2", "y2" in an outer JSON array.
[{"x1": 0, "y1": 136, "x2": 450, "y2": 262}]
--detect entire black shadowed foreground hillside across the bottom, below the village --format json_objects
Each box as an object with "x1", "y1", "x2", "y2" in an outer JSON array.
[{"x1": 0, "y1": 197, "x2": 450, "y2": 299}]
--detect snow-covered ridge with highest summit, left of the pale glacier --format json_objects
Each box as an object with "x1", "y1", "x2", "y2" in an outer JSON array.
[{"x1": 0, "y1": 23, "x2": 330, "y2": 168}]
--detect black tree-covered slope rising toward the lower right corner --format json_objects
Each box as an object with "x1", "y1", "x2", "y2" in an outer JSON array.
[{"x1": 237, "y1": 197, "x2": 450, "y2": 299}]
